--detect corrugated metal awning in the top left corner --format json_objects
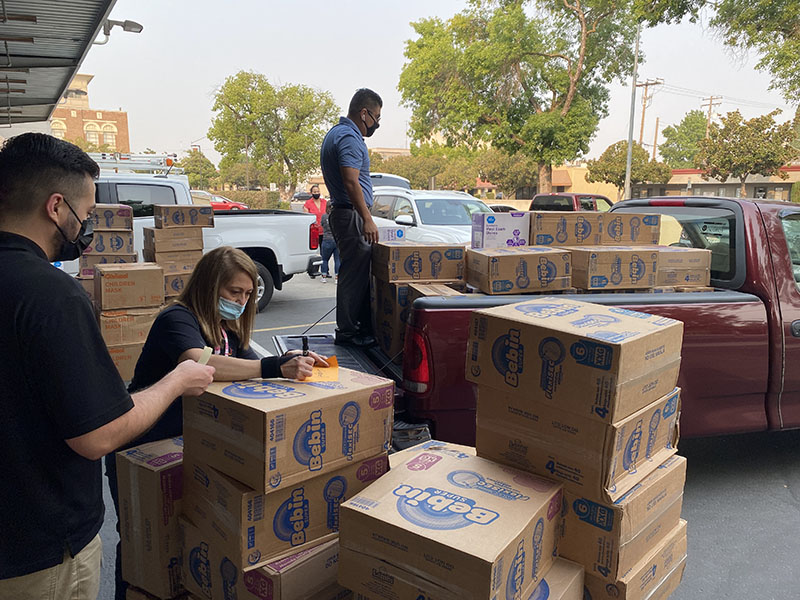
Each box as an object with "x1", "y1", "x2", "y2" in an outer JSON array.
[{"x1": 0, "y1": 0, "x2": 116, "y2": 125}]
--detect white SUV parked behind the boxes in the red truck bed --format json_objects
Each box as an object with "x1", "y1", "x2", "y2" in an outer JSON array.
[{"x1": 370, "y1": 186, "x2": 492, "y2": 245}]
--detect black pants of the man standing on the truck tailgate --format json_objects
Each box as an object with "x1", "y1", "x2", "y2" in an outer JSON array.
[{"x1": 328, "y1": 206, "x2": 372, "y2": 335}]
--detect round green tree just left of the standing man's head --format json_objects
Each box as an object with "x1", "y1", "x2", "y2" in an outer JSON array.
[{"x1": 208, "y1": 71, "x2": 339, "y2": 194}]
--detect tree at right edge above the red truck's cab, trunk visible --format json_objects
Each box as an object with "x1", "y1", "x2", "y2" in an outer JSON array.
[{"x1": 695, "y1": 110, "x2": 797, "y2": 197}]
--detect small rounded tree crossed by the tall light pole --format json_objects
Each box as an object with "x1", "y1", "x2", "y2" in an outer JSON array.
[{"x1": 586, "y1": 140, "x2": 672, "y2": 201}]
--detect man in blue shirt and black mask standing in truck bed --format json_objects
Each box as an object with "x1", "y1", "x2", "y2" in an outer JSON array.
[{"x1": 320, "y1": 88, "x2": 383, "y2": 346}]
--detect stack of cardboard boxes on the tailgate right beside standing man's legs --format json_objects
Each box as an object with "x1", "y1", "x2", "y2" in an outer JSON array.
[{"x1": 370, "y1": 241, "x2": 465, "y2": 363}]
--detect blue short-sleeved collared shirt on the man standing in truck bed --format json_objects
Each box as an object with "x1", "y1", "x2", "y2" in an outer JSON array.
[{"x1": 319, "y1": 117, "x2": 372, "y2": 206}]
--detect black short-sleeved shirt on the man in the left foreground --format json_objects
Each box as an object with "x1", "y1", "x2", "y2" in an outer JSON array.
[{"x1": 0, "y1": 232, "x2": 133, "y2": 579}]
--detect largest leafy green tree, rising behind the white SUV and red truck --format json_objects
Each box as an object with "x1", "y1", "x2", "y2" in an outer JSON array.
[{"x1": 399, "y1": 0, "x2": 636, "y2": 191}]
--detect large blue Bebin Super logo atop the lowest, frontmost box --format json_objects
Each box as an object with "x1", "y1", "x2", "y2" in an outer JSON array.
[{"x1": 394, "y1": 484, "x2": 500, "y2": 531}]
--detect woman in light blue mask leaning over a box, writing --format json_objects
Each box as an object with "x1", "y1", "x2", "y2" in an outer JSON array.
[{"x1": 106, "y1": 246, "x2": 327, "y2": 599}]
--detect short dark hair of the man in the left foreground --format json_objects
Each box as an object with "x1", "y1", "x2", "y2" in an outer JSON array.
[{"x1": 0, "y1": 133, "x2": 100, "y2": 218}]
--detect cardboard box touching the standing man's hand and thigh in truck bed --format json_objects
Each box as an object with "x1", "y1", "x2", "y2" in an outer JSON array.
[{"x1": 372, "y1": 242, "x2": 465, "y2": 282}]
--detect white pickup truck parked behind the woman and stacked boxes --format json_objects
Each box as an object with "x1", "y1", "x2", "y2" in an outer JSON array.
[{"x1": 60, "y1": 171, "x2": 322, "y2": 310}]
